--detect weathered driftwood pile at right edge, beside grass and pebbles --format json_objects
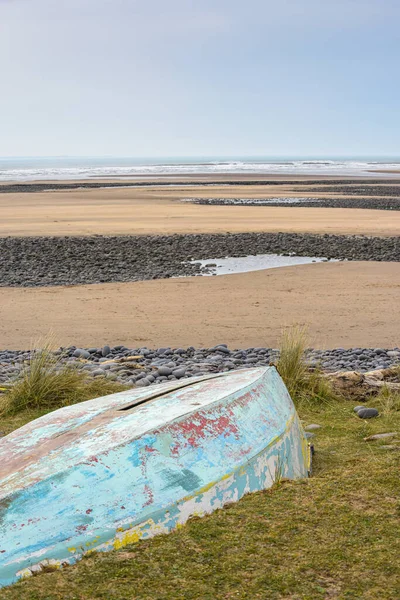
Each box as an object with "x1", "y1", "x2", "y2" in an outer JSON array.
[{"x1": 325, "y1": 367, "x2": 400, "y2": 397}]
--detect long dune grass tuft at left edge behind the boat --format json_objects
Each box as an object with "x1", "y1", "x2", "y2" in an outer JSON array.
[{"x1": 0, "y1": 346, "x2": 127, "y2": 417}]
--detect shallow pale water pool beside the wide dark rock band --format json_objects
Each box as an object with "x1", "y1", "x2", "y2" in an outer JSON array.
[{"x1": 190, "y1": 254, "x2": 337, "y2": 276}]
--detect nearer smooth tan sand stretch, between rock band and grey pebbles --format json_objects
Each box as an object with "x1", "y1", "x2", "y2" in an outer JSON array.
[{"x1": 0, "y1": 262, "x2": 400, "y2": 349}]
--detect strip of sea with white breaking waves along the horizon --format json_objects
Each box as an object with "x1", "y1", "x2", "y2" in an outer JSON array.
[{"x1": 0, "y1": 158, "x2": 400, "y2": 182}]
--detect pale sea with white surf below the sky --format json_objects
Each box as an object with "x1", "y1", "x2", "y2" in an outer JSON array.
[{"x1": 0, "y1": 156, "x2": 400, "y2": 182}]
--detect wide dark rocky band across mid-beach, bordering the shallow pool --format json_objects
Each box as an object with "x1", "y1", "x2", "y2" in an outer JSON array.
[{"x1": 0, "y1": 233, "x2": 400, "y2": 287}]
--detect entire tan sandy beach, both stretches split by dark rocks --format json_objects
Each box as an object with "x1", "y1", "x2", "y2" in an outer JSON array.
[{"x1": 0, "y1": 175, "x2": 400, "y2": 349}]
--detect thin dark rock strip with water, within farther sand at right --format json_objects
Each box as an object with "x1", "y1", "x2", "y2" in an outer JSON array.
[{"x1": 185, "y1": 197, "x2": 400, "y2": 210}]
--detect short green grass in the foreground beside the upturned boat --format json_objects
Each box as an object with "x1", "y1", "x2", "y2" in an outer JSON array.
[{"x1": 0, "y1": 400, "x2": 400, "y2": 600}]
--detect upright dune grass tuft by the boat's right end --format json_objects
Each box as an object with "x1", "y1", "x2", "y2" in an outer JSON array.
[{"x1": 276, "y1": 326, "x2": 336, "y2": 404}]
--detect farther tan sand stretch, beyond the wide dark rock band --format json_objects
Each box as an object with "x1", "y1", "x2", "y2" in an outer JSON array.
[{"x1": 0, "y1": 185, "x2": 400, "y2": 236}]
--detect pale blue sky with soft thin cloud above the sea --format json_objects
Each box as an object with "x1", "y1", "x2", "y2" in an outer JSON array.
[{"x1": 0, "y1": 0, "x2": 400, "y2": 157}]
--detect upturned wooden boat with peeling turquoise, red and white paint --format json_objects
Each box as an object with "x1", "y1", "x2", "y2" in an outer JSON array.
[{"x1": 0, "y1": 367, "x2": 310, "y2": 586}]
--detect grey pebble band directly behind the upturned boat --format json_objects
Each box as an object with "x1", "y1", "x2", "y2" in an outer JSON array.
[{"x1": 0, "y1": 344, "x2": 400, "y2": 387}]
